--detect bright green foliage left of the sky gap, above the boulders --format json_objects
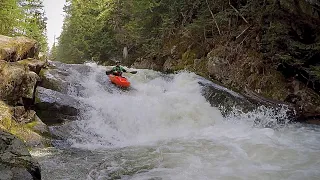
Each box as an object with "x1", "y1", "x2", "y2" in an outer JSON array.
[{"x1": 0, "y1": 0, "x2": 47, "y2": 51}]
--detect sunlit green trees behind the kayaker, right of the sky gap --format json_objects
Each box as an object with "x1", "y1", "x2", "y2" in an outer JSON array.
[{"x1": 56, "y1": 0, "x2": 235, "y2": 63}]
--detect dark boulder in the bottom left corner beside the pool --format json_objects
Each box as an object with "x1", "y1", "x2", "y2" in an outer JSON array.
[{"x1": 0, "y1": 130, "x2": 41, "y2": 180}]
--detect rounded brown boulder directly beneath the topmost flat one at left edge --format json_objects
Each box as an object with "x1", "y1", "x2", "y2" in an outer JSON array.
[{"x1": 0, "y1": 61, "x2": 40, "y2": 105}]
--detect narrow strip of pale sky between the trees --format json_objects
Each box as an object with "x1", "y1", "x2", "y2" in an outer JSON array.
[{"x1": 43, "y1": 0, "x2": 65, "y2": 48}]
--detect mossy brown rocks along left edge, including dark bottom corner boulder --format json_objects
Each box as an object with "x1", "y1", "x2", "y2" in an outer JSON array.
[{"x1": 0, "y1": 35, "x2": 51, "y2": 180}]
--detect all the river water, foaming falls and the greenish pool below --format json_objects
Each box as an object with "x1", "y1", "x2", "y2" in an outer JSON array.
[{"x1": 32, "y1": 64, "x2": 320, "y2": 180}]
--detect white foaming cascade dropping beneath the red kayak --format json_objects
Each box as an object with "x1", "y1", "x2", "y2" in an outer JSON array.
[{"x1": 71, "y1": 65, "x2": 223, "y2": 148}]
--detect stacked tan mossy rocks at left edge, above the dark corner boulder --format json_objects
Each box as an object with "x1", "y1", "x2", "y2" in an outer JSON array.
[{"x1": 0, "y1": 36, "x2": 50, "y2": 146}]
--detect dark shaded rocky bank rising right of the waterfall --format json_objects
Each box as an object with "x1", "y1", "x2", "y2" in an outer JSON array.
[{"x1": 133, "y1": 0, "x2": 320, "y2": 124}]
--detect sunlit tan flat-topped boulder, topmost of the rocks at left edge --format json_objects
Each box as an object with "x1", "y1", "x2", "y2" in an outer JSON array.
[{"x1": 0, "y1": 35, "x2": 39, "y2": 62}]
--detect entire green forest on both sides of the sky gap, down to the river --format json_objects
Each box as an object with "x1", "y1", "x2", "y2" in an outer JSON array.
[{"x1": 0, "y1": 0, "x2": 320, "y2": 121}]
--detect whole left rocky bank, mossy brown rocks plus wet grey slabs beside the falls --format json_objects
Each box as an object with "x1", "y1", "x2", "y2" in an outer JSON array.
[{"x1": 0, "y1": 35, "x2": 96, "y2": 180}]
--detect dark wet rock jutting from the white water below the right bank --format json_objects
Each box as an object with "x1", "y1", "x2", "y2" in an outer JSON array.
[{"x1": 199, "y1": 81, "x2": 298, "y2": 127}]
